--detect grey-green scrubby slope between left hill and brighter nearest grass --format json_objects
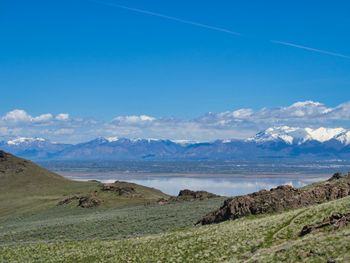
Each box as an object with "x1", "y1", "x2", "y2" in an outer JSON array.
[{"x1": 0, "y1": 198, "x2": 223, "y2": 245}]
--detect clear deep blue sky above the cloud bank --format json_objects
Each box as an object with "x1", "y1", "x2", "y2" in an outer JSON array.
[{"x1": 0, "y1": 0, "x2": 350, "y2": 142}]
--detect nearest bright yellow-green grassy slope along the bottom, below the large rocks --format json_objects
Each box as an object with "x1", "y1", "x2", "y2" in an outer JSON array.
[{"x1": 0, "y1": 197, "x2": 350, "y2": 262}]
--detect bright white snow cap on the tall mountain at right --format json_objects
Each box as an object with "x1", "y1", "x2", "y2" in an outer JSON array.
[{"x1": 248, "y1": 126, "x2": 350, "y2": 145}]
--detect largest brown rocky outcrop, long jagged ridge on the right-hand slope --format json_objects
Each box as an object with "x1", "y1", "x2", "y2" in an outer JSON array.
[{"x1": 198, "y1": 173, "x2": 350, "y2": 225}]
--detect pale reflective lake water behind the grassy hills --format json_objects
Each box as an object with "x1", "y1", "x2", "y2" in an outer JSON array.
[{"x1": 59, "y1": 171, "x2": 330, "y2": 196}]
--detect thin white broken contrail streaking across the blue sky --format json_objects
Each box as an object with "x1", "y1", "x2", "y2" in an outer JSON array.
[{"x1": 88, "y1": 0, "x2": 350, "y2": 59}]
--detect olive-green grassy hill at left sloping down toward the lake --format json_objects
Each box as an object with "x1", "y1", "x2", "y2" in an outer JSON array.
[{"x1": 0, "y1": 151, "x2": 167, "y2": 222}]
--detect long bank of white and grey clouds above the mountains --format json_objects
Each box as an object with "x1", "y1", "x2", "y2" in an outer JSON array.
[{"x1": 0, "y1": 101, "x2": 350, "y2": 143}]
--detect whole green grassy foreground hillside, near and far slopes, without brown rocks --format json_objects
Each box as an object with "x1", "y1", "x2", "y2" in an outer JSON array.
[{"x1": 0, "y1": 152, "x2": 350, "y2": 263}]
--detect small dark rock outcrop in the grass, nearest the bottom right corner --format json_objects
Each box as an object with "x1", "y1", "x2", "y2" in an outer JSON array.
[{"x1": 299, "y1": 213, "x2": 350, "y2": 237}]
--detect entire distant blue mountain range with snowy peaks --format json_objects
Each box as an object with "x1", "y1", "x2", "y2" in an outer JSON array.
[{"x1": 0, "y1": 126, "x2": 350, "y2": 161}]
